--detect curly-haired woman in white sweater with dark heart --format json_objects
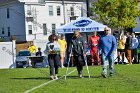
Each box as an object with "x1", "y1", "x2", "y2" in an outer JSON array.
[{"x1": 46, "y1": 34, "x2": 60, "y2": 80}]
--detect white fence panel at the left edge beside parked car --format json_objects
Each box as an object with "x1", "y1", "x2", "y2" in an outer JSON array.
[{"x1": 0, "y1": 40, "x2": 16, "y2": 69}]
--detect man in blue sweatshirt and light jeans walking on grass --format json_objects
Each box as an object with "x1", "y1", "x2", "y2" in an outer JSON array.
[{"x1": 98, "y1": 27, "x2": 117, "y2": 78}]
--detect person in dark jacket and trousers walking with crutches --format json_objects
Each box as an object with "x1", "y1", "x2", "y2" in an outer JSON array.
[{"x1": 68, "y1": 30, "x2": 86, "y2": 78}]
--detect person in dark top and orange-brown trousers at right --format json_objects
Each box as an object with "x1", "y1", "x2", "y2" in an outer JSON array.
[{"x1": 125, "y1": 32, "x2": 132, "y2": 65}]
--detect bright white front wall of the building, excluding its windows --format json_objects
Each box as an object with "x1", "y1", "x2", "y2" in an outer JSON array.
[{"x1": 25, "y1": 2, "x2": 83, "y2": 41}]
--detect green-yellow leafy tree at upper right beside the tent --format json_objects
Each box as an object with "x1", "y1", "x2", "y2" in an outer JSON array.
[{"x1": 91, "y1": 0, "x2": 140, "y2": 30}]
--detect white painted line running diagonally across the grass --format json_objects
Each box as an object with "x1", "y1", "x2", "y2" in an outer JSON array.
[{"x1": 24, "y1": 69, "x2": 76, "y2": 93}]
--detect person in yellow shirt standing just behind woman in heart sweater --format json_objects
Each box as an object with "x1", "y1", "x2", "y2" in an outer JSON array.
[{"x1": 58, "y1": 34, "x2": 67, "y2": 68}]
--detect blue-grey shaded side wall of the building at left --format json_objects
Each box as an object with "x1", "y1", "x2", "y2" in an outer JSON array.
[{"x1": 0, "y1": 3, "x2": 25, "y2": 41}]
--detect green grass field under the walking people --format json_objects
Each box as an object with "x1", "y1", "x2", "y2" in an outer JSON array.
[{"x1": 0, "y1": 64, "x2": 140, "y2": 93}]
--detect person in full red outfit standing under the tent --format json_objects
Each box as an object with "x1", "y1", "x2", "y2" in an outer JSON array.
[{"x1": 89, "y1": 32, "x2": 100, "y2": 65}]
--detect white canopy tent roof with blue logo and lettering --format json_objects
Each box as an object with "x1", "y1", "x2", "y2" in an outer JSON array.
[{"x1": 55, "y1": 17, "x2": 106, "y2": 34}]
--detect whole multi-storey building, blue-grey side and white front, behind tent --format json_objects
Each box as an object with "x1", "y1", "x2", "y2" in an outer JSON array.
[{"x1": 0, "y1": 0, "x2": 86, "y2": 42}]
